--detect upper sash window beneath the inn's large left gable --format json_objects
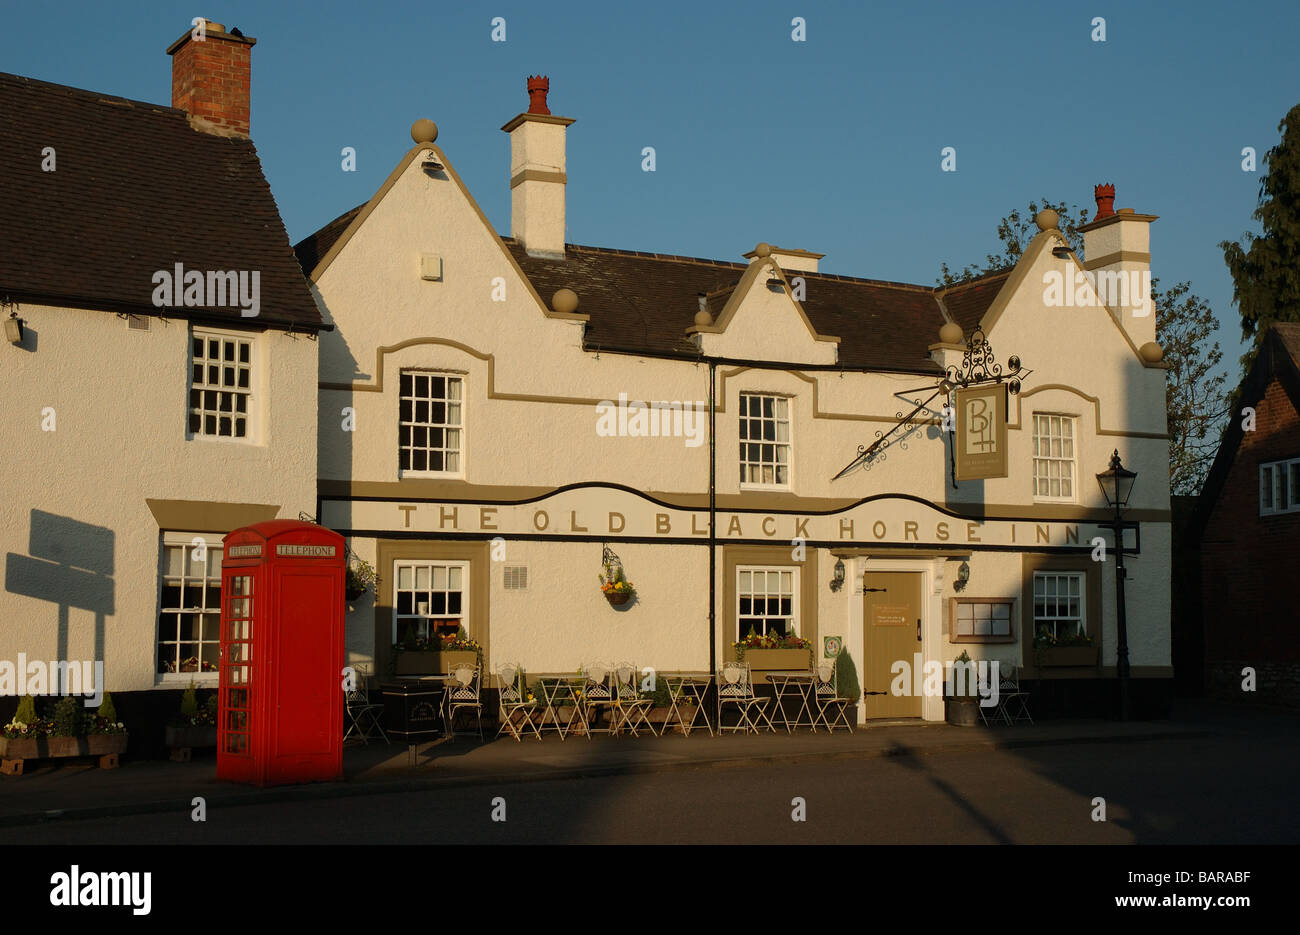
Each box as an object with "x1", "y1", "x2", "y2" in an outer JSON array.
[{"x1": 398, "y1": 371, "x2": 464, "y2": 473}]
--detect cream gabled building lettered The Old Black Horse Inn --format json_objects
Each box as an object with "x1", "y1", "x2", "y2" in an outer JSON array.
[{"x1": 296, "y1": 78, "x2": 1171, "y2": 719}]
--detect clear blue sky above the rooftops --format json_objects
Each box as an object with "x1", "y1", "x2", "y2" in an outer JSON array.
[{"x1": 0, "y1": 0, "x2": 1300, "y2": 381}]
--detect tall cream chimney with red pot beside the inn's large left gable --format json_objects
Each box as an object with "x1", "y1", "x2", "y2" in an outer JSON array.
[{"x1": 502, "y1": 75, "x2": 573, "y2": 259}]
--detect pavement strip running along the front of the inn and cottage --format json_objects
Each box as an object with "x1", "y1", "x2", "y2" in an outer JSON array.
[{"x1": 0, "y1": 701, "x2": 1279, "y2": 827}]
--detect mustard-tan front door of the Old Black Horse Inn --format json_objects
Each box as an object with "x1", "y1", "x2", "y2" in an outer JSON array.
[{"x1": 862, "y1": 571, "x2": 922, "y2": 718}]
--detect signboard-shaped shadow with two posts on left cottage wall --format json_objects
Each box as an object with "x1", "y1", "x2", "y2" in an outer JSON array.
[{"x1": 4, "y1": 510, "x2": 116, "y2": 659}]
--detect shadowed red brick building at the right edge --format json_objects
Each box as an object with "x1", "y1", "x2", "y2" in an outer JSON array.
[{"x1": 1190, "y1": 324, "x2": 1300, "y2": 705}]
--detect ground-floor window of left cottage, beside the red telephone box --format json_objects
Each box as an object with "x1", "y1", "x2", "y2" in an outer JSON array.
[{"x1": 157, "y1": 533, "x2": 221, "y2": 674}]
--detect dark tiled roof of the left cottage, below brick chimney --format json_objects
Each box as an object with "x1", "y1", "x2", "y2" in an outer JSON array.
[{"x1": 0, "y1": 73, "x2": 321, "y2": 328}]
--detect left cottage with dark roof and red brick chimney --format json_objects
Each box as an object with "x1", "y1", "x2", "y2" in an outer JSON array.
[{"x1": 0, "y1": 23, "x2": 324, "y2": 746}]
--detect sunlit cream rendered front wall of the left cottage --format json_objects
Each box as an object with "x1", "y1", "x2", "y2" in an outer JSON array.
[{"x1": 0, "y1": 304, "x2": 317, "y2": 692}]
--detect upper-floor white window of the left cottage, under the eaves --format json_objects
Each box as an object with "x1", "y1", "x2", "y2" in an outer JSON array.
[{"x1": 190, "y1": 329, "x2": 254, "y2": 438}]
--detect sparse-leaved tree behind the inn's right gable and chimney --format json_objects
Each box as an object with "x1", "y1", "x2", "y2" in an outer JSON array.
[{"x1": 937, "y1": 199, "x2": 1229, "y2": 494}]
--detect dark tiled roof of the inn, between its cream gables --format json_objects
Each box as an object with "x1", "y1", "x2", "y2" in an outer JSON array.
[{"x1": 295, "y1": 205, "x2": 1010, "y2": 372}]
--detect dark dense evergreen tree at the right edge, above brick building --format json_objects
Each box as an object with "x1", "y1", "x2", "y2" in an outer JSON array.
[{"x1": 1219, "y1": 104, "x2": 1300, "y2": 371}]
